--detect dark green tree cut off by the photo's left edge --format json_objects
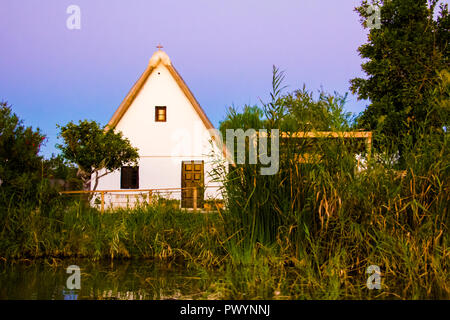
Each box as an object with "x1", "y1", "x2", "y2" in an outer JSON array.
[{"x1": 0, "y1": 102, "x2": 45, "y2": 193}]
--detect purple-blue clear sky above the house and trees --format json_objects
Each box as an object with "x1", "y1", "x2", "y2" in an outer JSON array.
[{"x1": 0, "y1": 0, "x2": 367, "y2": 157}]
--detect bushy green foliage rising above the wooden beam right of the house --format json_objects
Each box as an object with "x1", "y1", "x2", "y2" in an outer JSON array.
[{"x1": 220, "y1": 66, "x2": 354, "y2": 136}]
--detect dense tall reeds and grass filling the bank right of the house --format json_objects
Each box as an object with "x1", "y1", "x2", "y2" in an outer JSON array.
[{"x1": 209, "y1": 66, "x2": 450, "y2": 299}]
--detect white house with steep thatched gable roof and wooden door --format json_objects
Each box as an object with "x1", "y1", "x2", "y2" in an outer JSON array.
[{"x1": 93, "y1": 50, "x2": 222, "y2": 207}]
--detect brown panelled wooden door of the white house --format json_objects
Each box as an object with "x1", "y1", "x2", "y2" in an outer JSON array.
[{"x1": 181, "y1": 160, "x2": 204, "y2": 208}]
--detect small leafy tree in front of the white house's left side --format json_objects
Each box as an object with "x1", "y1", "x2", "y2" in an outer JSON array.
[{"x1": 57, "y1": 120, "x2": 139, "y2": 190}]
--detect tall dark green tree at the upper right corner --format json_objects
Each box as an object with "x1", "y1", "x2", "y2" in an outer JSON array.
[{"x1": 351, "y1": 0, "x2": 450, "y2": 156}]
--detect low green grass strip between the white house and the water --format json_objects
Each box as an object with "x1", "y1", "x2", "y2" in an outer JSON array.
[{"x1": 0, "y1": 201, "x2": 225, "y2": 265}]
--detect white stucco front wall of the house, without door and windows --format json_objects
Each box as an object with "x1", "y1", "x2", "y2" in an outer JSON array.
[{"x1": 91, "y1": 51, "x2": 221, "y2": 206}]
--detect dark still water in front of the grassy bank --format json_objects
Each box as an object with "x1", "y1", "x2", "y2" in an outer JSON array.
[{"x1": 0, "y1": 259, "x2": 218, "y2": 300}]
